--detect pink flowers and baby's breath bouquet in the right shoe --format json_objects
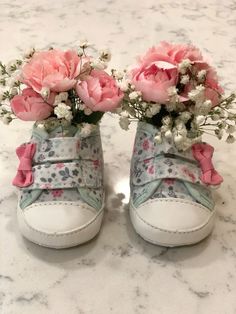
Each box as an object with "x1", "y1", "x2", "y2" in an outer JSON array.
[{"x1": 116, "y1": 42, "x2": 236, "y2": 150}]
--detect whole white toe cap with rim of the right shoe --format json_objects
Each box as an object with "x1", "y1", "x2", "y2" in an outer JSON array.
[{"x1": 130, "y1": 198, "x2": 215, "y2": 246}]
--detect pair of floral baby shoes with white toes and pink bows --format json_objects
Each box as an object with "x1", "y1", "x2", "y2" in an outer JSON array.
[{"x1": 13, "y1": 122, "x2": 219, "y2": 249}]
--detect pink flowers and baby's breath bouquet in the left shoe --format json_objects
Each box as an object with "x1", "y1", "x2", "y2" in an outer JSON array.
[{"x1": 0, "y1": 41, "x2": 123, "y2": 132}]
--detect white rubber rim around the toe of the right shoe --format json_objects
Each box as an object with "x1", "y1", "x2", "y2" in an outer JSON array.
[{"x1": 129, "y1": 202, "x2": 216, "y2": 247}]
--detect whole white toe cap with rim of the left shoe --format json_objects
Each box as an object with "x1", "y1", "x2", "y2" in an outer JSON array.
[{"x1": 18, "y1": 202, "x2": 102, "y2": 248}]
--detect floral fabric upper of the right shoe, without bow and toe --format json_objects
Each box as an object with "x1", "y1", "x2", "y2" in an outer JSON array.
[{"x1": 131, "y1": 122, "x2": 213, "y2": 208}]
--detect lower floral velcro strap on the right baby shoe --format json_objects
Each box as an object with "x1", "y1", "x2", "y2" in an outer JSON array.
[{"x1": 132, "y1": 155, "x2": 202, "y2": 185}]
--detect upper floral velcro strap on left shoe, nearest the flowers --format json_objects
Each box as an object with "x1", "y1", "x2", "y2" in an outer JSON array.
[{"x1": 33, "y1": 135, "x2": 101, "y2": 164}]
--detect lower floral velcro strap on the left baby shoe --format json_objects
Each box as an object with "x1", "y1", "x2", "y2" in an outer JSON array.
[{"x1": 24, "y1": 160, "x2": 102, "y2": 190}]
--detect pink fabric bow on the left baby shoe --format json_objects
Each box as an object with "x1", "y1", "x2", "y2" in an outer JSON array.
[{"x1": 12, "y1": 143, "x2": 36, "y2": 188}]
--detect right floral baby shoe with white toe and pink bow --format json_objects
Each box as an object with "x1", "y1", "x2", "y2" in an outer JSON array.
[{"x1": 130, "y1": 122, "x2": 222, "y2": 247}]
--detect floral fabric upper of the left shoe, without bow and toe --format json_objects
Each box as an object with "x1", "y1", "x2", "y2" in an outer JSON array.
[{"x1": 20, "y1": 127, "x2": 104, "y2": 209}]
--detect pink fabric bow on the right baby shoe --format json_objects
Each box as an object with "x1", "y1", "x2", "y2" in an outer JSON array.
[{"x1": 192, "y1": 143, "x2": 223, "y2": 185}]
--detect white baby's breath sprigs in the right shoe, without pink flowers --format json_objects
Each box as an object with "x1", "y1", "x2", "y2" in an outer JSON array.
[{"x1": 115, "y1": 68, "x2": 236, "y2": 150}]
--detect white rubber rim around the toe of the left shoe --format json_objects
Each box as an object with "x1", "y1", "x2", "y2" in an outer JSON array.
[{"x1": 17, "y1": 207, "x2": 104, "y2": 249}]
